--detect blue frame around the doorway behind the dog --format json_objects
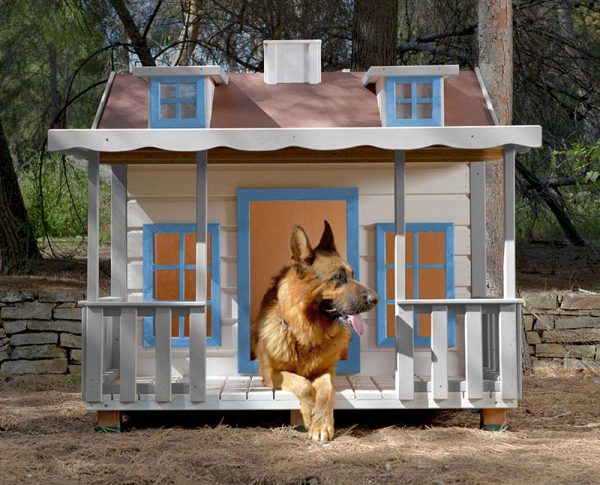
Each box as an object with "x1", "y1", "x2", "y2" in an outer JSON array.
[{"x1": 237, "y1": 188, "x2": 360, "y2": 374}]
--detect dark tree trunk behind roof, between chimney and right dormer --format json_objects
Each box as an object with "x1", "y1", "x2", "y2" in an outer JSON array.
[{"x1": 352, "y1": 0, "x2": 398, "y2": 71}]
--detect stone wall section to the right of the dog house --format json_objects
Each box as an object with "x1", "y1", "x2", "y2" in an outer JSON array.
[{"x1": 522, "y1": 292, "x2": 600, "y2": 370}]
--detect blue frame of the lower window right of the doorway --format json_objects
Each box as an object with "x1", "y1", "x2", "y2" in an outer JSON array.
[{"x1": 375, "y1": 222, "x2": 456, "y2": 347}]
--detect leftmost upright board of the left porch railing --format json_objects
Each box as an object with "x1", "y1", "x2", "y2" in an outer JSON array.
[{"x1": 85, "y1": 307, "x2": 104, "y2": 402}]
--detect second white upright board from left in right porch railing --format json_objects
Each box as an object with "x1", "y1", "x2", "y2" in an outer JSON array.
[{"x1": 431, "y1": 305, "x2": 448, "y2": 399}]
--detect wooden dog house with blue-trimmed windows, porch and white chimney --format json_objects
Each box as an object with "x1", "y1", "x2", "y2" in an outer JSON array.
[{"x1": 49, "y1": 41, "x2": 541, "y2": 430}]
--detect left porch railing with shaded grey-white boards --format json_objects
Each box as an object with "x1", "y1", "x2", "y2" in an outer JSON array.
[{"x1": 79, "y1": 298, "x2": 206, "y2": 403}]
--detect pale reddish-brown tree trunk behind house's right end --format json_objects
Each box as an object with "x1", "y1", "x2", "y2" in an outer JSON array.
[{"x1": 478, "y1": 0, "x2": 513, "y2": 296}]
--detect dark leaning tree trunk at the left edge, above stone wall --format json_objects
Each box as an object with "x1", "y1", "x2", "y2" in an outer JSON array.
[{"x1": 0, "y1": 119, "x2": 40, "y2": 273}]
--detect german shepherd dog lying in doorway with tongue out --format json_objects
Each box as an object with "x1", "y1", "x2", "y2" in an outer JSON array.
[{"x1": 251, "y1": 221, "x2": 378, "y2": 441}]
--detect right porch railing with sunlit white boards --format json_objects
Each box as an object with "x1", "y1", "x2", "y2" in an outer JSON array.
[{"x1": 396, "y1": 299, "x2": 522, "y2": 400}]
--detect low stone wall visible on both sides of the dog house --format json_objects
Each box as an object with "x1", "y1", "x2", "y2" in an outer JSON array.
[{"x1": 0, "y1": 291, "x2": 600, "y2": 375}]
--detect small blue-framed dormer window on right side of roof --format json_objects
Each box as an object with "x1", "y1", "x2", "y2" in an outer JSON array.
[{"x1": 385, "y1": 76, "x2": 442, "y2": 126}]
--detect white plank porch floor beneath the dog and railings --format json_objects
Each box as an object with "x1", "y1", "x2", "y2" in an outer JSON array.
[{"x1": 94, "y1": 371, "x2": 516, "y2": 410}]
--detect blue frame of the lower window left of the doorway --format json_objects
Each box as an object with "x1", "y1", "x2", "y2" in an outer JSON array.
[{"x1": 142, "y1": 223, "x2": 221, "y2": 348}]
